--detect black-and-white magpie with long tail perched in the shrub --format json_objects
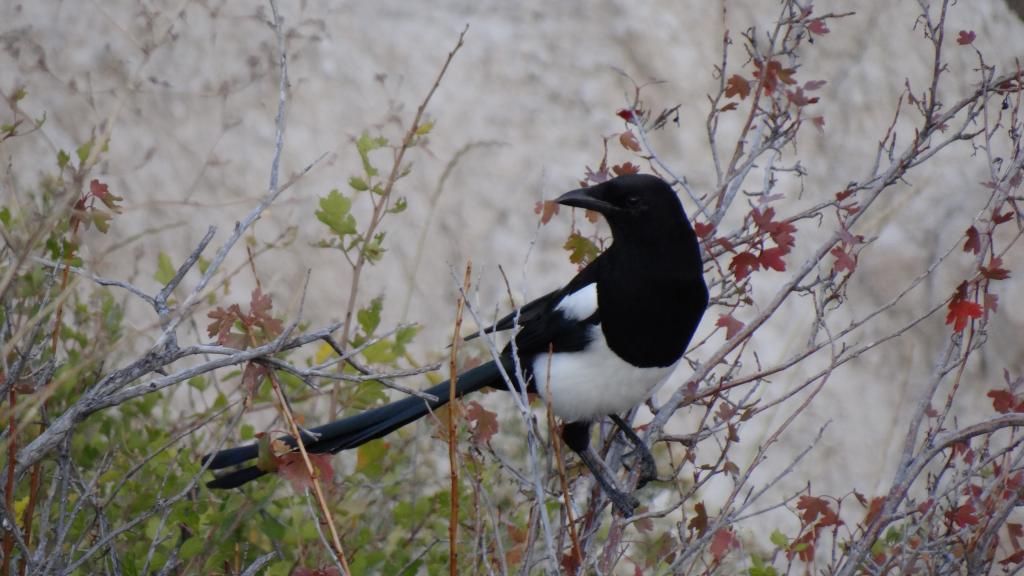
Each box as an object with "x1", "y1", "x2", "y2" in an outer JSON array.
[{"x1": 204, "y1": 174, "x2": 708, "y2": 517}]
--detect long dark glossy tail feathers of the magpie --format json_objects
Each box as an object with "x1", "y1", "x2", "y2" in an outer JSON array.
[{"x1": 203, "y1": 358, "x2": 514, "y2": 489}]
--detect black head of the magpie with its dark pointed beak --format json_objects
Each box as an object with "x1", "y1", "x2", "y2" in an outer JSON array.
[{"x1": 555, "y1": 174, "x2": 693, "y2": 238}]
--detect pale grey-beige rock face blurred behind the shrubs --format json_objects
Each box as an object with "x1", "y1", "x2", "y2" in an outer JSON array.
[{"x1": 0, "y1": 0, "x2": 1024, "y2": 528}]
